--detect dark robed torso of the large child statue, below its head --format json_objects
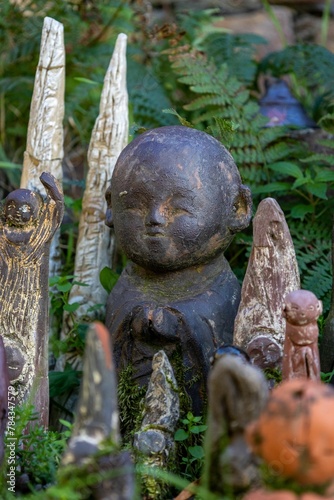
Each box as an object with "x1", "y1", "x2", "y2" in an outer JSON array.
[{"x1": 107, "y1": 256, "x2": 240, "y2": 409}]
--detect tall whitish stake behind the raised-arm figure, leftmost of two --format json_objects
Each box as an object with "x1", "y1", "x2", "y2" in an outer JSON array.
[{"x1": 20, "y1": 17, "x2": 65, "y2": 282}]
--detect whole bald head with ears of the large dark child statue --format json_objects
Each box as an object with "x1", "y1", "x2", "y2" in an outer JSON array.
[{"x1": 106, "y1": 126, "x2": 252, "y2": 272}]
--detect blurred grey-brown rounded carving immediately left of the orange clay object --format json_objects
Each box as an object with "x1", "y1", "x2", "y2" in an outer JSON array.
[{"x1": 204, "y1": 354, "x2": 268, "y2": 494}]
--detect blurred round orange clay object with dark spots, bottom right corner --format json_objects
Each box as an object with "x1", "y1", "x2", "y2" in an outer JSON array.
[{"x1": 246, "y1": 379, "x2": 334, "y2": 486}]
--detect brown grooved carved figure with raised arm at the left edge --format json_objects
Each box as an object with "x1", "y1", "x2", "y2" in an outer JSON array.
[{"x1": 0, "y1": 172, "x2": 64, "y2": 426}]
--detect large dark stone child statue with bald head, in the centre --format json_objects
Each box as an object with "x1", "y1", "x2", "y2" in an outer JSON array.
[{"x1": 106, "y1": 126, "x2": 251, "y2": 411}]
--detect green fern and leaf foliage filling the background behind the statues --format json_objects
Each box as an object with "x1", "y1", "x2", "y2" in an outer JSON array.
[{"x1": 0, "y1": 0, "x2": 334, "y2": 498}]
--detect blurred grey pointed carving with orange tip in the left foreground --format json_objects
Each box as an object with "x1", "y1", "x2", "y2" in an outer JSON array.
[{"x1": 61, "y1": 322, "x2": 134, "y2": 500}]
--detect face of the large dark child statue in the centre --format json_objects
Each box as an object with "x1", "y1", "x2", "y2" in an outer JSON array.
[{"x1": 111, "y1": 161, "x2": 230, "y2": 271}]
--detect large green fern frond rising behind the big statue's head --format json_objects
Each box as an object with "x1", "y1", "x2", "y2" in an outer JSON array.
[{"x1": 169, "y1": 41, "x2": 296, "y2": 172}]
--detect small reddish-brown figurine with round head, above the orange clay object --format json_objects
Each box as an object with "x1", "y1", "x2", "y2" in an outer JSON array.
[{"x1": 282, "y1": 290, "x2": 322, "y2": 380}]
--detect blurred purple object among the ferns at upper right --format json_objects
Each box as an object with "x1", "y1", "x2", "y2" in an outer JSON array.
[{"x1": 260, "y1": 80, "x2": 316, "y2": 128}]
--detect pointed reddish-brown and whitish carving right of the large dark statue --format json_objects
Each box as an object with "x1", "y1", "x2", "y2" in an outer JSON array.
[{"x1": 233, "y1": 198, "x2": 300, "y2": 368}]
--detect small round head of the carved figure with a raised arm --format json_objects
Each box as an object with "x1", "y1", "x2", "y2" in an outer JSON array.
[{"x1": 4, "y1": 189, "x2": 41, "y2": 227}]
